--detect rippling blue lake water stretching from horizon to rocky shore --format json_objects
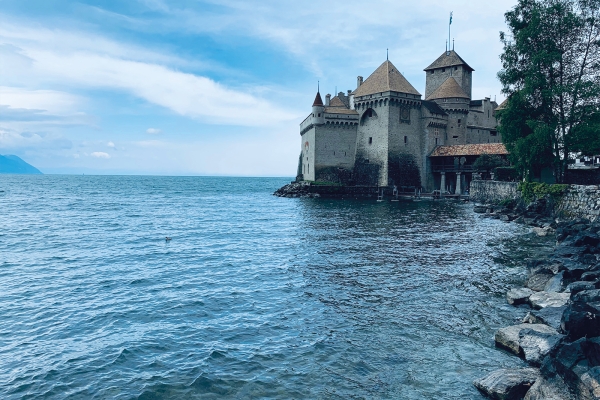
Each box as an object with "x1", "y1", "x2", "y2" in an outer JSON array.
[{"x1": 0, "y1": 175, "x2": 547, "y2": 399}]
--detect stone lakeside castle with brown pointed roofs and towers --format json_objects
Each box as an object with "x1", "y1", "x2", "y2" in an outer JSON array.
[{"x1": 297, "y1": 50, "x2": 507, "y2": 194}]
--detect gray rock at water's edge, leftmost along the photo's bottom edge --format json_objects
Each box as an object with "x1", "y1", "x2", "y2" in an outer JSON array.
[{"x1": 473, "y1": 368, "x2": 540, "y2": 400}]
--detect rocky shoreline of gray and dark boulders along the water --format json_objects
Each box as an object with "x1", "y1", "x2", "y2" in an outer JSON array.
[{"x1": 473, "y1": 199, "x2": 600, "y2": 400}]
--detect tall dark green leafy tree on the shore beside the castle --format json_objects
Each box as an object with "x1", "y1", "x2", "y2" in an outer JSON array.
[{"x1": 498, "y1": 0, "x2": 600, "y2": 182}]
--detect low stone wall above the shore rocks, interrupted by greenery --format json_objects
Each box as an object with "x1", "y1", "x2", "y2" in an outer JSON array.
[{"x1": 471, "y1": 181, "x2": 600, "y2": 221}]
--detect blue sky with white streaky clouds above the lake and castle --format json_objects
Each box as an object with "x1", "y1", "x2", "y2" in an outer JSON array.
[{"x1": 0, "y1": 0, "x2": 516, "y2": 177}]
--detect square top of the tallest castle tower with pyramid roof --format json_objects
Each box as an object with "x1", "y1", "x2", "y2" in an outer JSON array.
[{"x1": 424, "y1": 50, "x2": 475, "y2": 99}]
